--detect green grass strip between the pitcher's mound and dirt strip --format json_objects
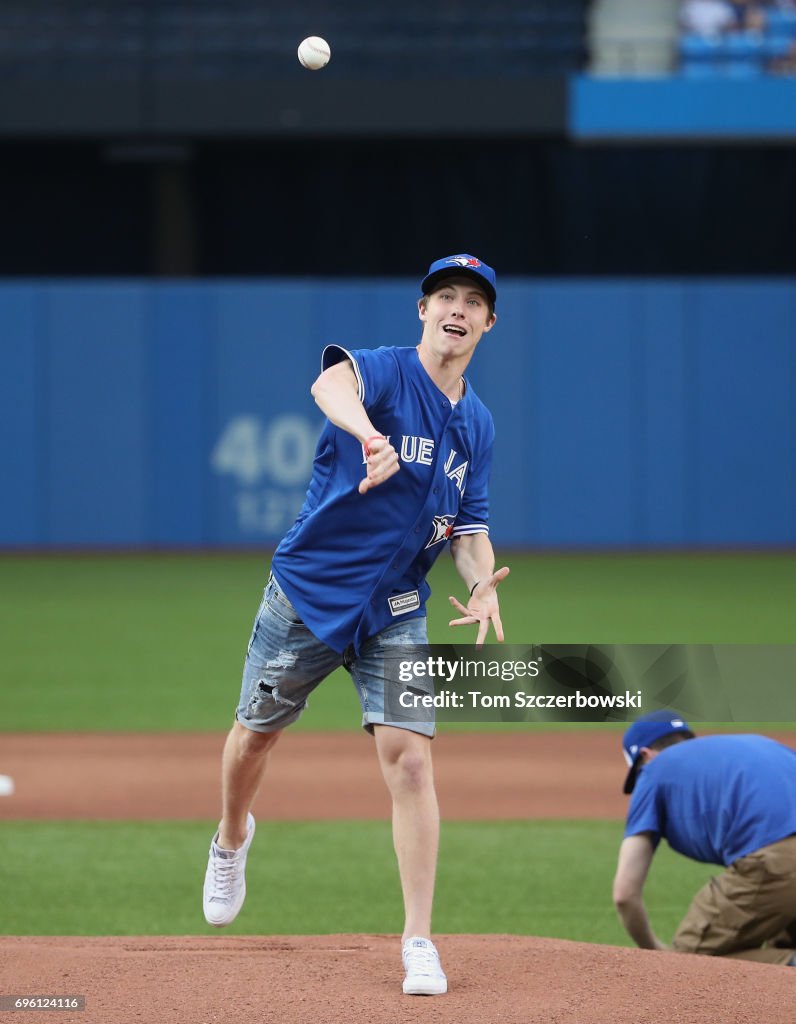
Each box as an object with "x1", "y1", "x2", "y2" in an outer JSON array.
[{"x1": 0, "y1": 821, "x2": 710, "y2": 945}]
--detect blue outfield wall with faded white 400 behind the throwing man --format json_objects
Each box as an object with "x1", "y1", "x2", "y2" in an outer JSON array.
[{"x1": 0, "y1": 280, "x2": 796, "y2": 548}]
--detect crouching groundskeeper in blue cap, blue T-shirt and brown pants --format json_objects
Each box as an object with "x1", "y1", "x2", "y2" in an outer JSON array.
[{"x1": 614, "y1": 712, "x2": 796, "y2": 967}]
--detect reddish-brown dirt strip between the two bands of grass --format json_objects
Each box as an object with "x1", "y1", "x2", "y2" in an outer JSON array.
[{"x1": 0, "y1": 732, "x2": 626, "y2": 820}]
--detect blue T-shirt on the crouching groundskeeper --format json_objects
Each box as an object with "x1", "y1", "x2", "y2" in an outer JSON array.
[{"x1": 625, "y1": 735, "x2": 796, "y2": 866}]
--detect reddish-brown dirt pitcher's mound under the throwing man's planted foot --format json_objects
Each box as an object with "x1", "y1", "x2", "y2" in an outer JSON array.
[{"x1": 0, "y1": 934, "x2": 796, "y2": 1024}]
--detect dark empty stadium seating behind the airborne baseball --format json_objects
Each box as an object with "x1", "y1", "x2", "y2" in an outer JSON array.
[{"x1": 0, "y1": 0, "x2": 588, "y2": 80}]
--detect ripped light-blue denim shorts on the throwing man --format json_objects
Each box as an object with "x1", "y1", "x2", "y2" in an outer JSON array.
[{"x1": 236, "y1": 577, "x2": 435, "y2": 736}]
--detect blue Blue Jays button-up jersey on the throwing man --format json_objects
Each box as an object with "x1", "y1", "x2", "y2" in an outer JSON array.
[{"x1": 273, "y1": 345, "x2": 495, "y2": 652}]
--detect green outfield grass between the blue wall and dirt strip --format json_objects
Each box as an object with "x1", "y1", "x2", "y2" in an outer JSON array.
[{"x1": 0, "y1": 552, "x2": 796, "y2": 732}]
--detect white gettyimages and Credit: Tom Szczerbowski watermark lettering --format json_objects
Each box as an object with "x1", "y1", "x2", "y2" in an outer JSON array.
[{"x1": 397, "y1": 654, "x2": 642, "y2": 711}]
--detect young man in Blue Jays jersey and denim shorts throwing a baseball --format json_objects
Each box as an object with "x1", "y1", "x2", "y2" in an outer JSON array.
[{"x1": 204, "y1": 255, "x2": 509, "y2": 995}]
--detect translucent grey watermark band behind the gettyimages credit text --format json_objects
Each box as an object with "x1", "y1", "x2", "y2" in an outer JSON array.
[{"x1": 382, "y1": 644, "x2": 796, "y2": 724}]
